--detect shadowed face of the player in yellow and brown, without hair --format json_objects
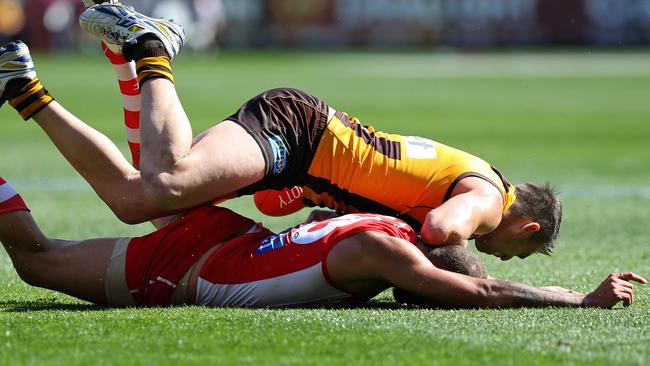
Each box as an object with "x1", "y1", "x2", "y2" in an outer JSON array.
[{"x1": 474, "y1": 217, "x2": 539, "y2": 261}]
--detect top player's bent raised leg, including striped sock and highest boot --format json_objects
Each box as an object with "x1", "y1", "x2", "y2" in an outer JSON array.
[{"x1": 80, "y1": 5, "x2": 265, "y2": 210}]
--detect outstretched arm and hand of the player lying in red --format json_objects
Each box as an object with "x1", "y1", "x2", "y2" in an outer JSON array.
[{"x1": 362, "y1": 234, "x2": 647, "y2": 308}]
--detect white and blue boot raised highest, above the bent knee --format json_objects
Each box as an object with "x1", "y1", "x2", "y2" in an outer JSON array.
[{"x1": 79, "y1": 4, "x2": 185, "y2": 60}]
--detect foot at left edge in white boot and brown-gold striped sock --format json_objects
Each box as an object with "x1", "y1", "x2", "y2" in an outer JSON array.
[{"x1": 0, "y1": 41, "x2": 54, "y2": 120}]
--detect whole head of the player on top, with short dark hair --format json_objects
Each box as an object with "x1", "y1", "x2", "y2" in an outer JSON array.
[{"x1": 476, "y1": 183, "x2": 562, "y2": 260}]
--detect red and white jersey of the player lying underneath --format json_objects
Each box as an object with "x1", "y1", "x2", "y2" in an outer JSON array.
[{"x1": 196, "y1": 214, "x2": 417, "y2": 307}]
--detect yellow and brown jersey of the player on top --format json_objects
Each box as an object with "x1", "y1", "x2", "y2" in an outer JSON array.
[{"x1": 303, "y1": 112, "x2": 515, "y2": 229}]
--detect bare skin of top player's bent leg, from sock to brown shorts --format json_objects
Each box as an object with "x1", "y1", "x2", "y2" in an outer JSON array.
[{"x1": 140, "y1": 79, "x2": 265, "y2": 209}]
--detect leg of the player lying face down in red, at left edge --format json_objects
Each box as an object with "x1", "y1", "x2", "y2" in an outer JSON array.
[{"x1": 0, "y1": 178, "x2": 117, "y2": 303}]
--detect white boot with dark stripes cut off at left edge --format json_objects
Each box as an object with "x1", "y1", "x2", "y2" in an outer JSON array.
[{"x1": 0, "y1": 41, "x2": 36, "y2": 106}]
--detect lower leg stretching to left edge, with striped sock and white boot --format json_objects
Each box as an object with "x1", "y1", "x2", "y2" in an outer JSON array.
[{"x1": 0, "y1": 42, "x2": 168, "y2": 223}]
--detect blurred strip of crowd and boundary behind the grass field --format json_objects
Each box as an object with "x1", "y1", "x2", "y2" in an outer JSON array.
[{"x1": 0, "y1": 0, "x2": 650, "y2": 52}]
